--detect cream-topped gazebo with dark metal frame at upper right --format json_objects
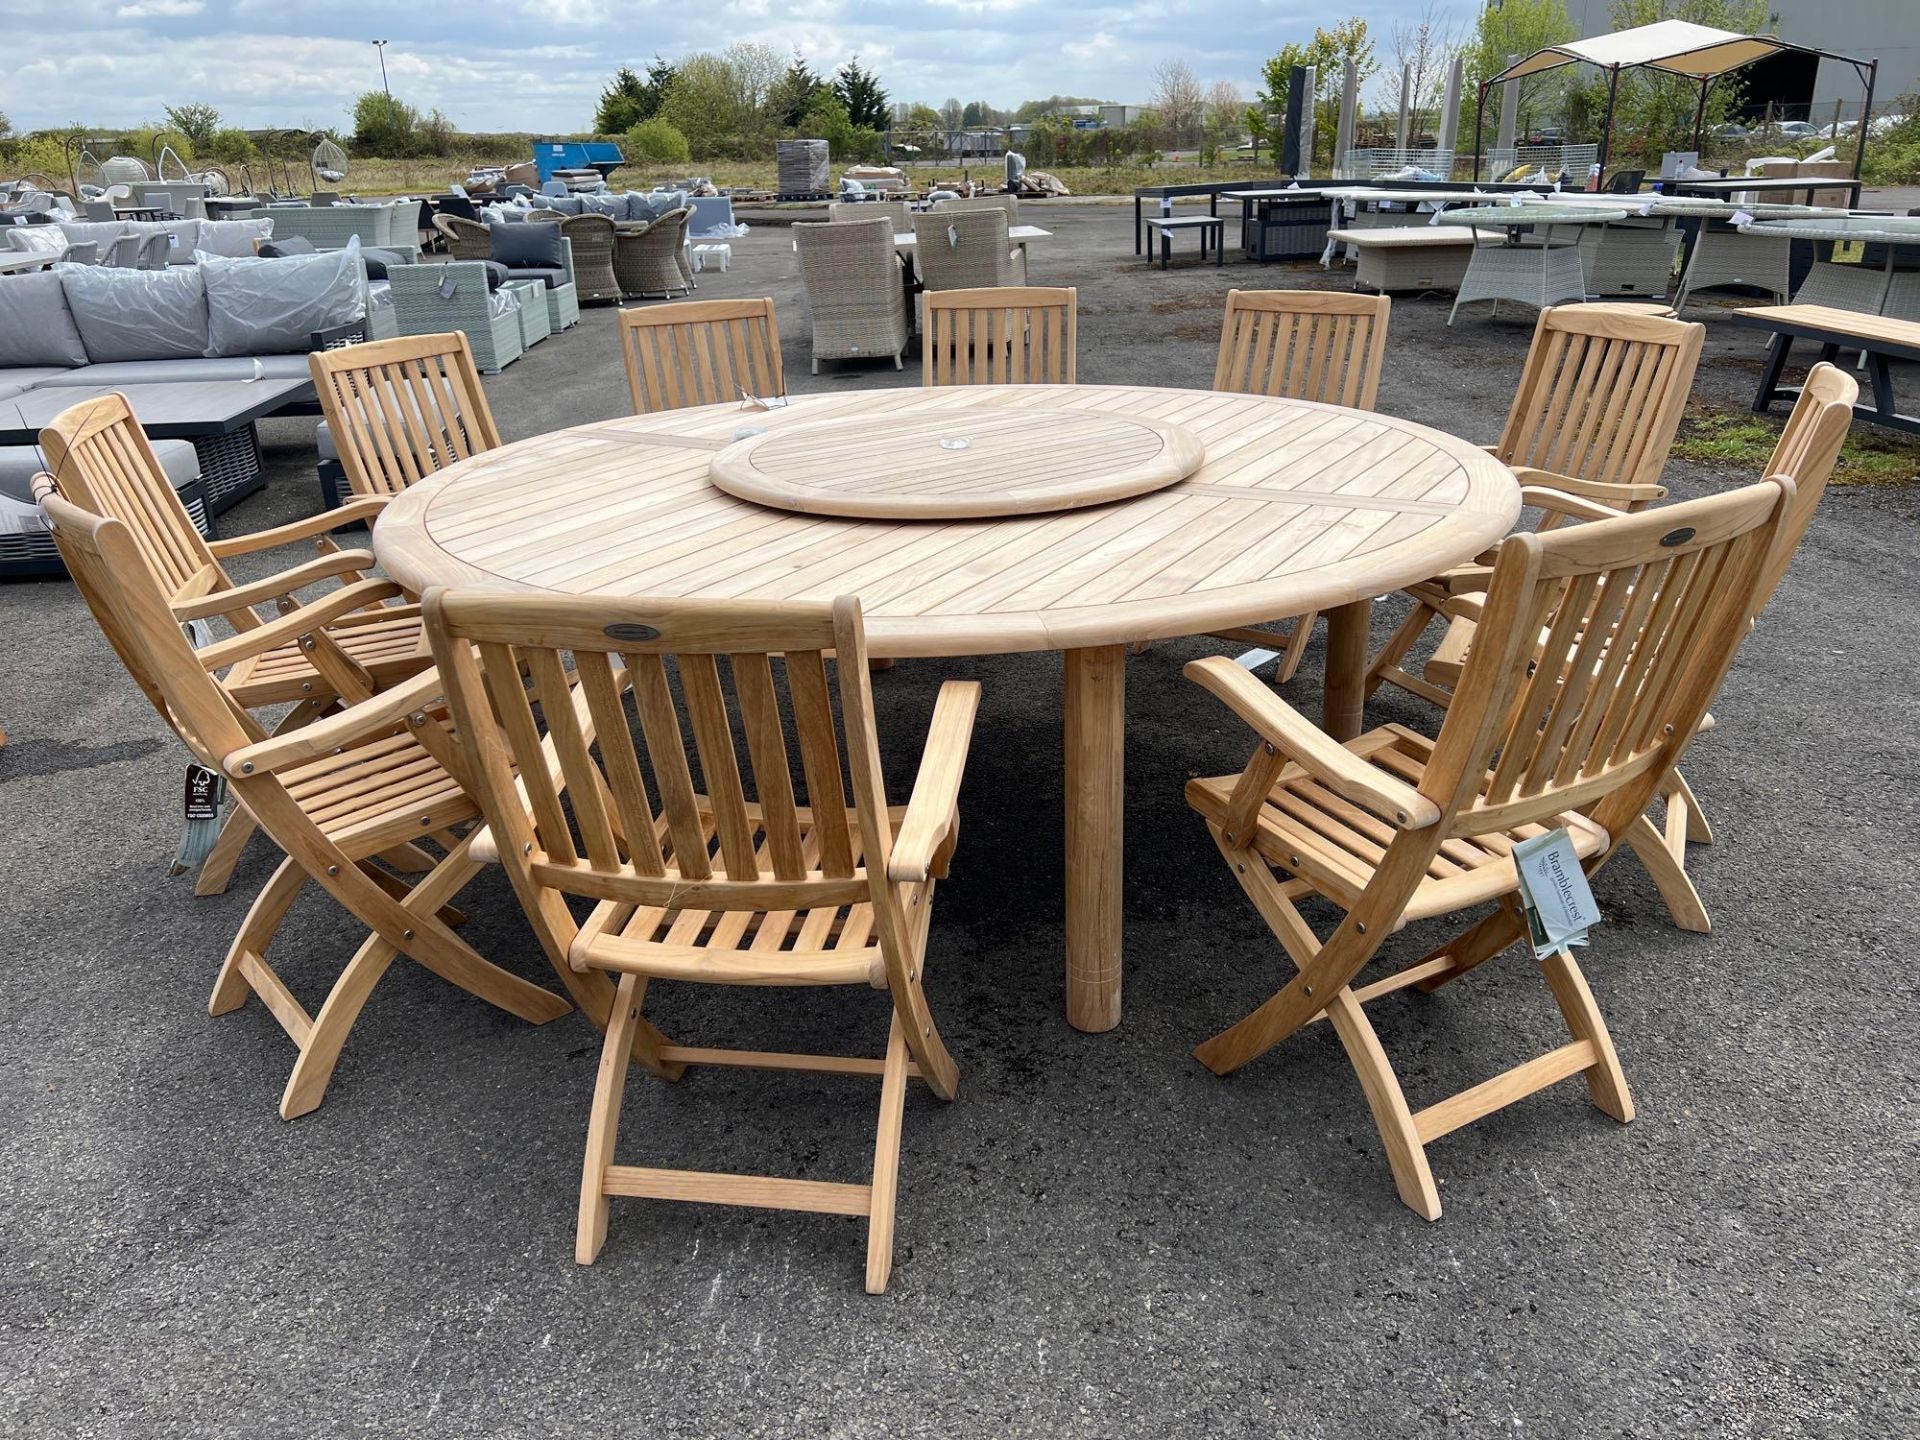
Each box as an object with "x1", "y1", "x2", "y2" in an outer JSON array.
[{"x1": 1473, "y1": 19, "x2": 1880, "y2": 179}]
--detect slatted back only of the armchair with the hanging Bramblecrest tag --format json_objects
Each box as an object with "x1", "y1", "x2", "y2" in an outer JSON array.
[{"x1": 1421, "y1": 478, "x2": 1793, "y2": 841}]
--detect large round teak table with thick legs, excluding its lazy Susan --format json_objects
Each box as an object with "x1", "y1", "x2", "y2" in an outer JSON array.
[{"x1": 372, "y1": 386, "x2": 1521, "y2": 1031}]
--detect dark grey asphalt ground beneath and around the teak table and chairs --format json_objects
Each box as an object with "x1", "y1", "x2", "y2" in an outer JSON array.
[{"x1": 0, "y1": 205, "x2": 1920, "y2": 1438}]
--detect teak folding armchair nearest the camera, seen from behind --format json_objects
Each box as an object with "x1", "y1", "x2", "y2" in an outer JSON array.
[{"x1": 426, "y1": 589, "x2": 979, "y2": 1292}]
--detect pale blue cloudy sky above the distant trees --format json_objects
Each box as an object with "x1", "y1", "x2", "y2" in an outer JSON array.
[{"x1": 0, "y1": 0, "x2": 1443, "y2": 131}]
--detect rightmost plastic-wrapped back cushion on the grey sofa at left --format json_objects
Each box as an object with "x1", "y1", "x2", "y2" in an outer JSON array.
[{"x1": 200, "y1": 240, "x2": 367, "y2": 355}]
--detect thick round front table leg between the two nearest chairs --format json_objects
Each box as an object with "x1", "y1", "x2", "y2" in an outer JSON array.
[{"x1": 1066, "y1": 645, "x2": 1127, "y2": 1031}]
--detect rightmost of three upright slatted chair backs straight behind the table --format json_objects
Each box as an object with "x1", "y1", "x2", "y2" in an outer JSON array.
[{"x1": 1213, "y1": 290, "x2": 1392, "y2": 411}]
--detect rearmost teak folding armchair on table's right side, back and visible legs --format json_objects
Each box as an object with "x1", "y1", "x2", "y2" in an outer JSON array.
[{"x1": 1365, "y1": 305, "x2": 1707, "y2": 705}]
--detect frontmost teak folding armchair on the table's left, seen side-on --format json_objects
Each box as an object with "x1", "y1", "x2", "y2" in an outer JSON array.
[{"x1": 40, "y1": 486, "x2": 570, "y2": 1119}]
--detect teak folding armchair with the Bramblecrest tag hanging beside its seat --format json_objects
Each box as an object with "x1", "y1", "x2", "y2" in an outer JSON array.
[{"x1": 1187, "y1": 480, "x2": 1793, "y2": 1219}]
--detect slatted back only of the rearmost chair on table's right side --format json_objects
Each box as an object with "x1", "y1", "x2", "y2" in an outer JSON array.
[{"x1": 1494, "y1": 305, "x2": 1707, "y2": 509}]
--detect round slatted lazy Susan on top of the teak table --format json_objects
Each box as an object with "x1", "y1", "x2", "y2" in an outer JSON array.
[{"x1": 710, "y1": 396, "x2": 1206, "y2": 520}]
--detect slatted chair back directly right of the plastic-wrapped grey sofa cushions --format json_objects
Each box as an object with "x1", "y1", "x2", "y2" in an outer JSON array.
[{"x1": 307, "y1": 330, "x2": 499, "y2": 495}]
